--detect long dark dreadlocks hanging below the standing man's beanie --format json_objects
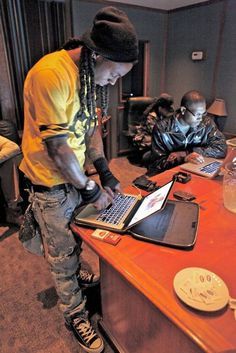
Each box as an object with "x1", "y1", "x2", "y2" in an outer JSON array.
[{"x1": 62, "y1": 38, "x2": 108, "y2": 129}]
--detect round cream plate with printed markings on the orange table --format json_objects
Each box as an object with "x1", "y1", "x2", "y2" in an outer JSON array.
[{"x1": 174, "y1": 267, "x2": 229, "y2": 311}]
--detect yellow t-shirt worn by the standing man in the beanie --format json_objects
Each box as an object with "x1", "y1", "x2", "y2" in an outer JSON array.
[{"x1": 20, "y1": 50, "x2": 88, "y2": 187}]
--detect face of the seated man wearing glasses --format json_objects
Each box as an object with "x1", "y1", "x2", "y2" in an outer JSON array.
[{"x1": 183, "y1": 102, "x2": 206, "y2": 128}]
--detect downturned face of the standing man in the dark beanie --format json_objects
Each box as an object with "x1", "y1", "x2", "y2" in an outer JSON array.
[{"x1": 95, "y1": 56, "x2": 133, "y2": 86}]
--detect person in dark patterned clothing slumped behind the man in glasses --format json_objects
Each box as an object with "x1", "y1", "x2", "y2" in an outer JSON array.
[{"x1": 133, "y1": 93, "x2": 174, "y2": 164}]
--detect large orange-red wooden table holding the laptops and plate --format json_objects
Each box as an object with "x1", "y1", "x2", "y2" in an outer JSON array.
[{"x1": 72, "y1": 168, "x2": 236, "y2": 353}]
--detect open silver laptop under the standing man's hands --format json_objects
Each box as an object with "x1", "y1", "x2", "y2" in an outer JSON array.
[{"x1": 74, "y1": 180, "x2": 174, "y2": 233}]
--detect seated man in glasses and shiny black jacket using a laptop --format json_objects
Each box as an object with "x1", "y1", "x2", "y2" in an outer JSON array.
[{"x1": 147, "y1": 91, "x2": 227, "y2": 176}]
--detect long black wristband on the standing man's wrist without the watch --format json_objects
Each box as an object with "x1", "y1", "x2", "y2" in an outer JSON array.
[{"x1": 93, "y1": 157, "x2": 119, "y2": 190}]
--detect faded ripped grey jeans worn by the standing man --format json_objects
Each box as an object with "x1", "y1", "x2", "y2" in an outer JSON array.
[{"x1": 29, "y1": 186, "x2": 86, "y2": 321}]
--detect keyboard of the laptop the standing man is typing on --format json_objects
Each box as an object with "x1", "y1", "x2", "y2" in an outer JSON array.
[{"x1": 97, "y1": 194, "x2": 137, "y2": 225}]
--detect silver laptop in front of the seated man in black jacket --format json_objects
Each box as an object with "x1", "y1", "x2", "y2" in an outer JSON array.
[{"x1": 180, "y1": 148, "x2": 236, "y2": 179}]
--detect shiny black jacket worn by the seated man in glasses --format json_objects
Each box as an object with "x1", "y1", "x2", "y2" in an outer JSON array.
[{"x1": 147, "y1": 115, "x2": 227, "y2": 175}]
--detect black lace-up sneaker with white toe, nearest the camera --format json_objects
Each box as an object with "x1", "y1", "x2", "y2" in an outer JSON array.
[{"x1": 69, "y1": 313, "x2": 104, "y2": 353}]
